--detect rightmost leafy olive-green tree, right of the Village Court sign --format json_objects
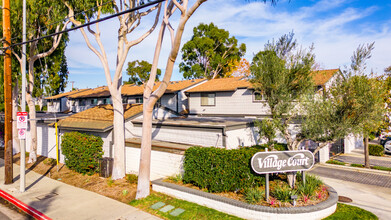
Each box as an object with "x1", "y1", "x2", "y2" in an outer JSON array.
[{"x1": 301, "y1": 44, "x2": 385, "y2": 167}]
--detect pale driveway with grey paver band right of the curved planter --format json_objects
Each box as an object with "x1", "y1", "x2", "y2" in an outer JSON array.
[{"x1": 309, "y1": 149, "x2": 391, "y2": 220}]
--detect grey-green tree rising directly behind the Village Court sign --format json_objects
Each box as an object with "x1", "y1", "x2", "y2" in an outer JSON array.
[{"x1": 251, "y1": 33, "x2": 314, "y2": 150}]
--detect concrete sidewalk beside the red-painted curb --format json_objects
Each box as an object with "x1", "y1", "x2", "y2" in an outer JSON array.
[{"x1": 0, "y1": 159, "x2": 159, "y2": 220}]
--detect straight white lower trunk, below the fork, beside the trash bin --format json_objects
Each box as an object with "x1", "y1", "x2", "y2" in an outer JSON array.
[{"x1": 111, "y1": 90, "x2": 126, "y2": 180}]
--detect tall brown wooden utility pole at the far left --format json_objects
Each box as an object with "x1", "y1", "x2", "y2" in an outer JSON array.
[{"x1": 3, "y1": 0, "x2": 13, "y2": 184}]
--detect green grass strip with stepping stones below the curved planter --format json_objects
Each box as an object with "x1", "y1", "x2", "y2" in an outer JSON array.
[{"x1": 130, "y1": 193, "x2": 241, "y2": 220}]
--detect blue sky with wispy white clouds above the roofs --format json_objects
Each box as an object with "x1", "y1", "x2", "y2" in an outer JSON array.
[{"x1": 66, "y1": 0, "x2": 391, "y2": 91}]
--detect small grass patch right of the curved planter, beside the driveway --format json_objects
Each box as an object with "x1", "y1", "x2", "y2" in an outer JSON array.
[{"x1": 324, "y1": 203, "x2": 378, "y2": 220}]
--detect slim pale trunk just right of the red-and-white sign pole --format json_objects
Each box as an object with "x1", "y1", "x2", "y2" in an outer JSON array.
[{"x1": 26, "y1": 93, "x2": 37, "y2": 163}]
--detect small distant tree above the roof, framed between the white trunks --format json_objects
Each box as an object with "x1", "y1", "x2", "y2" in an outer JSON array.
[{"x1": 125, "y1": 60, "x2": 162, "y2": 85}]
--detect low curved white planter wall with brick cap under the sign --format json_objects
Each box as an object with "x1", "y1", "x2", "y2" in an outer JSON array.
[{"x1": 152, "y1": 179, "x2": 338, "y2": 220}]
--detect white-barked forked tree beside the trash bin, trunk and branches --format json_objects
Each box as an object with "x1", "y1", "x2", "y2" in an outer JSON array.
[{"x1": 65, "y1": 0, "x2": 163, "y2": 179}]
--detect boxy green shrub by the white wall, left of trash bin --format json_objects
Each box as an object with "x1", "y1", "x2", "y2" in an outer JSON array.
[{"x1": 61, "y1": 132, "x2": 103, "y2": 175}]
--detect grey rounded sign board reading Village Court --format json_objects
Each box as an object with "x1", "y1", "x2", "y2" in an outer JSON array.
[{"x1": 251, "y1": 150, "x2": 315, "y2": 174}]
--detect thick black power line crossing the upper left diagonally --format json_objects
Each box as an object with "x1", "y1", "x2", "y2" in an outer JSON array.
[{"x1": 0, "y1": 0, "x2": 166, "y2": 50}]
